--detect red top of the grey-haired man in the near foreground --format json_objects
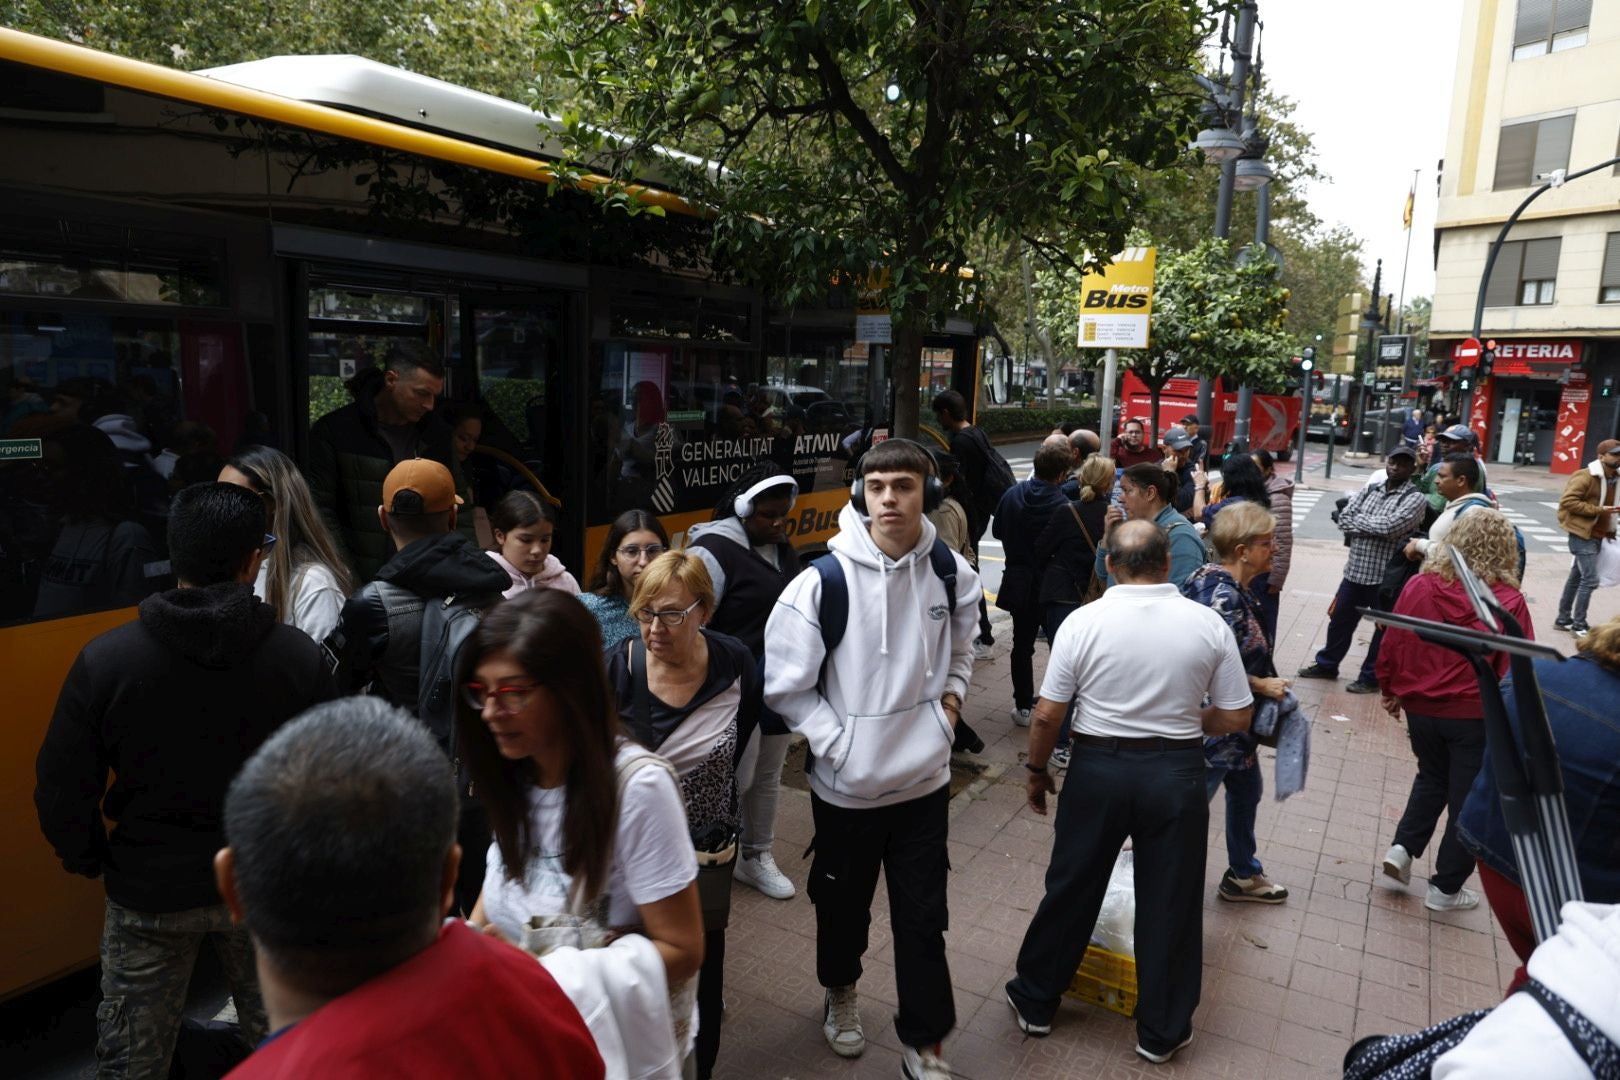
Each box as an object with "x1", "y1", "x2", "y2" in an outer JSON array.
[{"x1": 228, "y1": 921, "x2": 603, "y2": 1080}]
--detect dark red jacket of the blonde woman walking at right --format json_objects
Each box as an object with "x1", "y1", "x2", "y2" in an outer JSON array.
[{"x1": 1377, "y1": 573, "x2": 1534, "y2": 721}]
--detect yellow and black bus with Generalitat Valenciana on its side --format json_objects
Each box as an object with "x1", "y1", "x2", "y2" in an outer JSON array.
[{"x1": 0, "y1": 29, "x2": 977, "y2": 996}]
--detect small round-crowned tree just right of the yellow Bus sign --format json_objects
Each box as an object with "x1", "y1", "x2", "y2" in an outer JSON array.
[{"x1": 1124, "y1": 240, "x2": 1290, "y2": 431}]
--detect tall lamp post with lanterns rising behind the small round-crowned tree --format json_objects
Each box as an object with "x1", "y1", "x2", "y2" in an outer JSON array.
[{"x1": 1192, "y1": 0, "x2": 1272, "y2": 450}]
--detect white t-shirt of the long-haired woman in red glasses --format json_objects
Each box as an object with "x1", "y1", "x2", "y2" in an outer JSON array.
[{"x1": 484, "y1": 745, "x2": 698, "y2": 941}]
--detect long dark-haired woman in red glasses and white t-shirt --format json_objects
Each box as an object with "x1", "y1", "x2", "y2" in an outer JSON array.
[{"x1": 455, "y1": 589, "x2": 703, "y2": 1075}]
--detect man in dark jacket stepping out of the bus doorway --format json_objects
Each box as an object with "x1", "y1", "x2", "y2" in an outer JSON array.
[{"x1": 305, "y1": 342, "x2": 473, "y2": 581}]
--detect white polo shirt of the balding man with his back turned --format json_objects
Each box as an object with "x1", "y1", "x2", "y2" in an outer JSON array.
[{"x1": 1040, "y1": 585, "x2": 1254, "y2": 738}]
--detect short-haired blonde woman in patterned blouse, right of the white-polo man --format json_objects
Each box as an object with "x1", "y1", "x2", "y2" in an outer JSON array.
[{"x1": 1181, "y1": 505, "x2": 1288, "y2": 904}]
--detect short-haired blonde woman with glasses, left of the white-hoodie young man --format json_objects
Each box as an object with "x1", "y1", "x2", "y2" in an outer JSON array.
[{"x1": 608, "y1": 551, "x2": 763, "y2": 1080}]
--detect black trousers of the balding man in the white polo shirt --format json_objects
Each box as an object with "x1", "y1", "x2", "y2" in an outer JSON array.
[{"x1": 1006, "y1": 742, "x2": 1210, "y2": 1054}]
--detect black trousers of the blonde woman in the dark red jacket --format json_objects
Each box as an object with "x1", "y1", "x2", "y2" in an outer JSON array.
[{"x1": 1395, "y1": 712, "x2": 1486, "y2": 892}]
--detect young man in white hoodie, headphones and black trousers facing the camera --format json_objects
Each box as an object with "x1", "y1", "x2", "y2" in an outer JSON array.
[{"x1": 765, "y1": 439, "x2": 980, "y2": 1080}]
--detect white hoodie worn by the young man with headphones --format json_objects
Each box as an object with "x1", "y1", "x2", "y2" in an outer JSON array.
[{"x1": 765, "y1": 505, "x2": 978, "y2": 810}]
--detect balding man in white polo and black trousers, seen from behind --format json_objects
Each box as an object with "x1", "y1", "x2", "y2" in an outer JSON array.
[{"x1": 1006, "y1": 521, "x2": 1254, "y2": 1064}]
